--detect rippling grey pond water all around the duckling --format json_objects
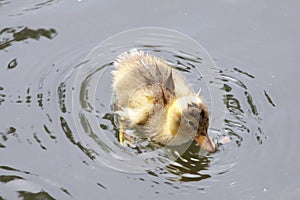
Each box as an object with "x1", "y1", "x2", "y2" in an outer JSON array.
[{"x1": 0, "y1": 0, "x2": 300, "y2": 199}]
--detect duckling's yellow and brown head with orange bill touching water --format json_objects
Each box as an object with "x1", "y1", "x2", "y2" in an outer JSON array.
[{"x1": 165, "y1": 95, "x2": 215, "y2": 152}]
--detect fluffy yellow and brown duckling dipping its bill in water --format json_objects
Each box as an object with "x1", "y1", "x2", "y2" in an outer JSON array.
[{"x1": 112, "y1": 49, "x2": 215, "y2": 152}]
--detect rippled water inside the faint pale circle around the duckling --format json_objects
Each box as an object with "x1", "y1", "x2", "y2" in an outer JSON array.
[{"x1": 72, "y1": 28, "x2": 225, "y2": 173}]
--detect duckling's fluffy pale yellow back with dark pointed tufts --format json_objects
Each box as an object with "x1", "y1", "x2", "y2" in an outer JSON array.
[{"x1": 112, "y1": 50, "x2": 191, "y2": 108}]
